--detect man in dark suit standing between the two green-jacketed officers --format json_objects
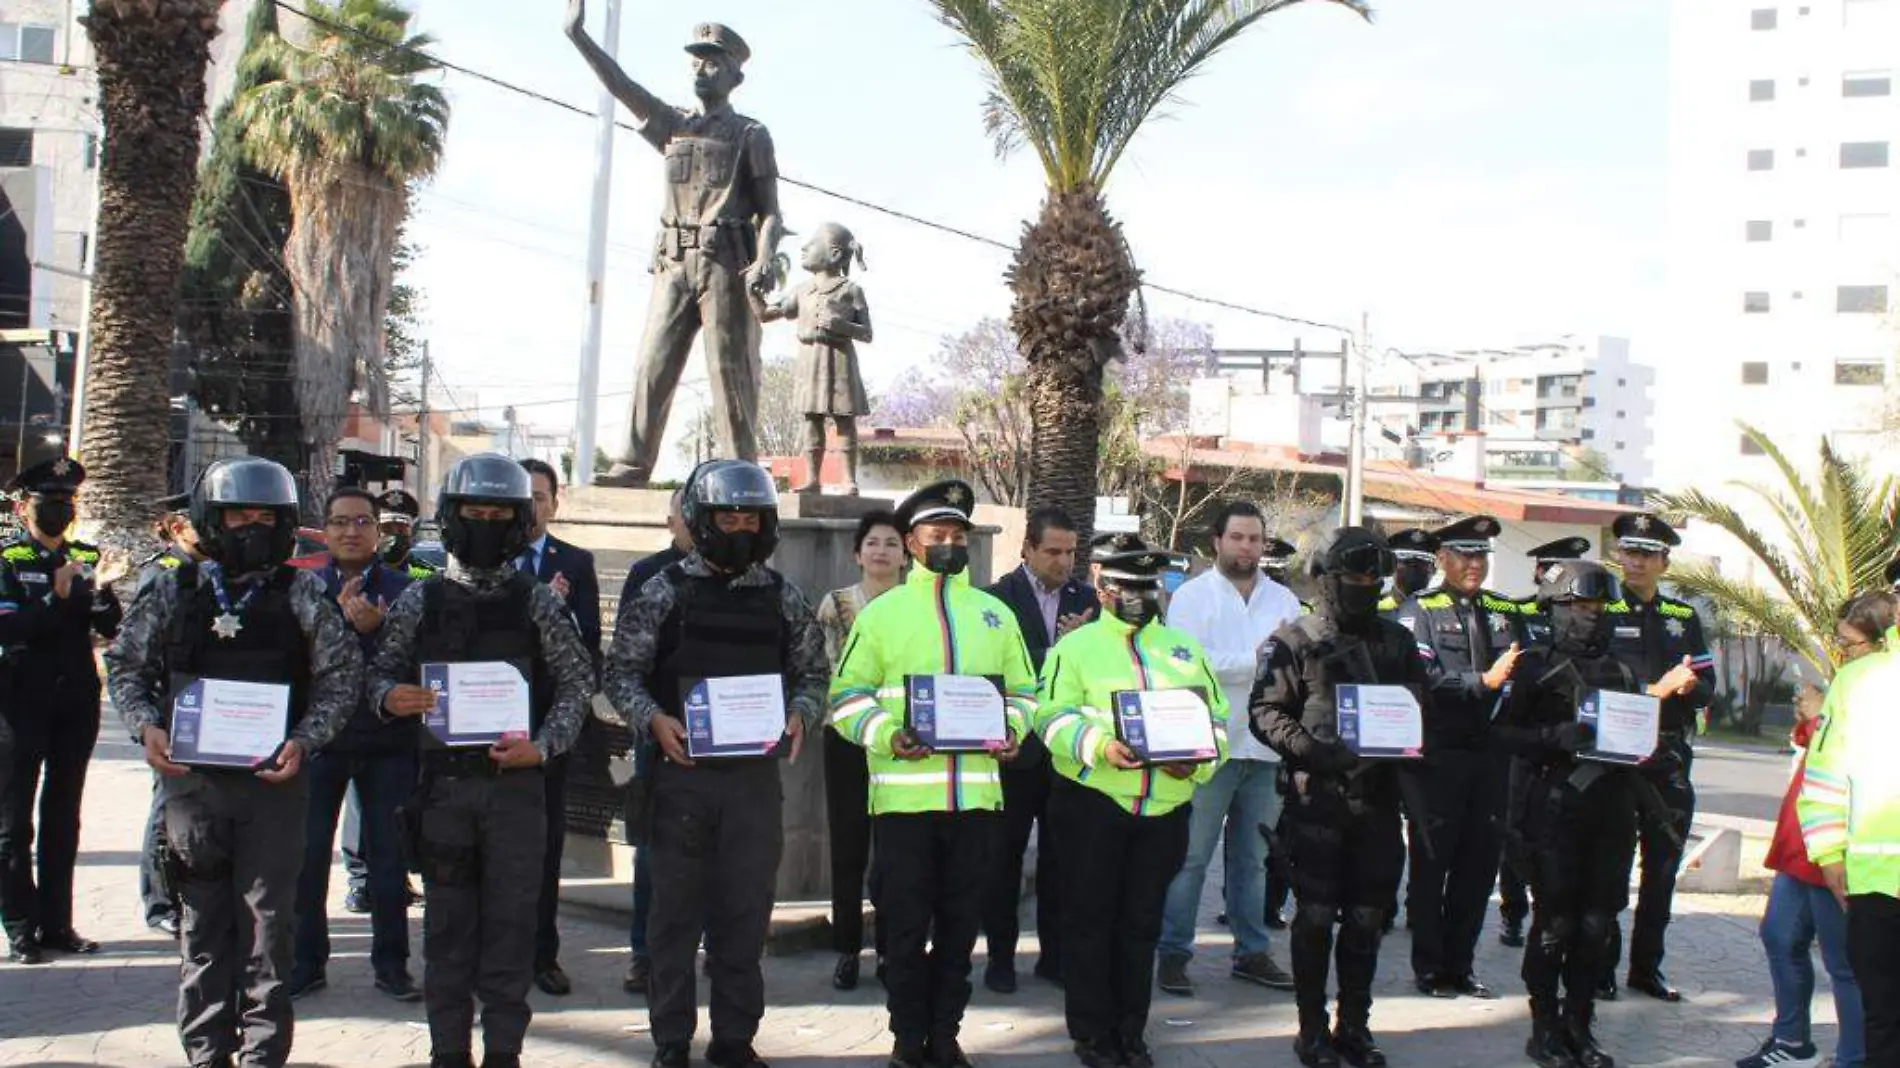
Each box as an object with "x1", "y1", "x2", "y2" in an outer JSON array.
[{"x1": 982, "y1": 507, "x2": 1100, "y2": 994}]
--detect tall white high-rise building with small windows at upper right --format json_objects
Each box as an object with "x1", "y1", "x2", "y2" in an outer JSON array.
[{"x1": 1657, "y1": 0, "x2": 1900, "y2": 486}]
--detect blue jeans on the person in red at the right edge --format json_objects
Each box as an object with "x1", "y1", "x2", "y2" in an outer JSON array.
[{"x1": 1761, "y1": 874, "x2": 1866, "y2": 1068}]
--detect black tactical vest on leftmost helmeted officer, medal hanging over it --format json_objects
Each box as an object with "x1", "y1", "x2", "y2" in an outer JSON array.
[{"x1": 160, "y1": 563, "x2": 310, "y2": 734}]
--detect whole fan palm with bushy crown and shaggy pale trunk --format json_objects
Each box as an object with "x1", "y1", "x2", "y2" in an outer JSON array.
[{"x1": 238, "y1": 0, "x2": 448, "y2": 498}]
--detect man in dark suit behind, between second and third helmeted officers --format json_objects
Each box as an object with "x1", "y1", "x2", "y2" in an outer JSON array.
[{"x1": 515, "y1": 460, "x2": 600, "y2": 996}]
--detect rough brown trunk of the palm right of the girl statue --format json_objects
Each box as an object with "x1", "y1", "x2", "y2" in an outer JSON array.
[{"x1": 1009, "y1": 188, "x2": 1142, "y2": 576}]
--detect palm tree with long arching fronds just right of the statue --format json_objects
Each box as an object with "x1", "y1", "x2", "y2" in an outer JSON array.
[{"x1": 931, "y1": 0, "x2": 1370, "y2": 570}]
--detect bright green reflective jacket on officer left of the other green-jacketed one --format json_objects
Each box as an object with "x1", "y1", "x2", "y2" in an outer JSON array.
[{"x1": 830, "y1": 566, "x2": 1036, "y2": 815}]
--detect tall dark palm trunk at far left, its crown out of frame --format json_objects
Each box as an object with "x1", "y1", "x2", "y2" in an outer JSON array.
[{"x1": 80, "y1": 0, "x2": 219, "y2": 538}]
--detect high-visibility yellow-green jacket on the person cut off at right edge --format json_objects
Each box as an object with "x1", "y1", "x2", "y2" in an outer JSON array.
[{"x1": 1796, "y1": 629, "x2": 1900, "y2": 897}]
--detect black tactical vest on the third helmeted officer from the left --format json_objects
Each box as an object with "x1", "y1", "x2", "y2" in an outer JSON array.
[{"x1": 652, "y1": 564, "x2": 790, "y2": 766}]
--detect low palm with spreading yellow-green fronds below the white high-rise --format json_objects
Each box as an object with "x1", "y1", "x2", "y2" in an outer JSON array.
[{"x1": 1655, "y1": 424, "x2": 1900, "y2": 678}]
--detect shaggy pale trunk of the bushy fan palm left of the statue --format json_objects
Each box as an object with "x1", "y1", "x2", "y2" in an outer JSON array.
[{"x1": 283, "y1": 167, "x2": 403, "y2": 505}]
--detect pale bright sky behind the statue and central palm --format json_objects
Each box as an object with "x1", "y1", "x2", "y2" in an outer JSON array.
[{"x1": 397, "y1": 0, "x2": 1668, "y2": 463}]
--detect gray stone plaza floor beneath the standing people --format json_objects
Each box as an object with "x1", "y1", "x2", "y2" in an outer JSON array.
[{"x1": 0, "y1": 730, "x2": 1834, "y2": 1068}]
